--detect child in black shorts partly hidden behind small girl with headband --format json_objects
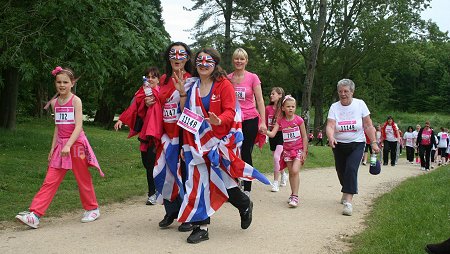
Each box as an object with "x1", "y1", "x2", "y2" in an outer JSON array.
[{"x1": 266, "y1": 87, "x2": 287, "y2": 192}]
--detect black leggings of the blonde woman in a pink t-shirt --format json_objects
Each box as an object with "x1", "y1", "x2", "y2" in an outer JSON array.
[{"x1": 241, "y1": 117, "x2": 258, "y2": 191}]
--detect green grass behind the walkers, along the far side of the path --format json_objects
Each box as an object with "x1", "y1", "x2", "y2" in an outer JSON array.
[{"x1": 0, "y1": 119, "x2": 334, "y2": 221}]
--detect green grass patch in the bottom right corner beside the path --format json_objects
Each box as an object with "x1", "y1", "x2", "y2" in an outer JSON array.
[{"x1": 351, "y1": 166, "x2": 450, "y2": 254}]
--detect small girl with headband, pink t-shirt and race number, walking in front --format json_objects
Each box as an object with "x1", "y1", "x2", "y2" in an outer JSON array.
[{"x1": 267, "y1": 95, "x2": 308, "y2": 207}]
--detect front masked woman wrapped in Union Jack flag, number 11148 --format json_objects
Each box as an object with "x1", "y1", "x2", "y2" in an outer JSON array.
[{"x1": 174, "y1": 48, "x2": 270, "y2": 243}]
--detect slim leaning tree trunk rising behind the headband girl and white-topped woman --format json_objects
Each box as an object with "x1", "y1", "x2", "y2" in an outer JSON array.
[{"x1": 302, "y1": 0, "x2": 327, "y2": 133}]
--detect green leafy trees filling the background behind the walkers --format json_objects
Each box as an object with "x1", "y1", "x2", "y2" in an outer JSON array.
[{"x1": 0, "y1": 0, "x2": 450, "y2": 133}]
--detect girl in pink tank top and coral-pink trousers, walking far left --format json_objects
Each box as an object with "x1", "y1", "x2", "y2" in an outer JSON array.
[{"x1": 16, "y1": 66, "x2": 104, "y2": 228}]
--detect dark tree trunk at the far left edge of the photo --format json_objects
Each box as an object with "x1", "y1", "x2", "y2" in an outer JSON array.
[{"x1": 0, "y1": 67, "x2": 19, "y2": 130}]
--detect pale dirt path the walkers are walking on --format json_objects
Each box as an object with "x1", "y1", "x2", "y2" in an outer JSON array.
[{"x1": 0, "y1": 160, "x2": 423, "y2": 254}]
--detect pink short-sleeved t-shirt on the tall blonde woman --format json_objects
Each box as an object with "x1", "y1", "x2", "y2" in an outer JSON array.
[{"x1": 228, "y1": 71, "x2": 261, "y2": 120}]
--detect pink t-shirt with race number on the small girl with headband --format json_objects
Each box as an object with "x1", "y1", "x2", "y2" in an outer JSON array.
[{"x1": 278, "y1": 115, "x2": 304, "y2": 151}]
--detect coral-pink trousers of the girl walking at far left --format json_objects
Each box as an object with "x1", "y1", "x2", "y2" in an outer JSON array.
[{"x1": 30, "y1": 143, "x2": 98, "y2": 217}]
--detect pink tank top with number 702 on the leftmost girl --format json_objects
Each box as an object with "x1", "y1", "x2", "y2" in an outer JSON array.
[{"x1": 55, "y1": 95, "x2": 81, "y2": 138}]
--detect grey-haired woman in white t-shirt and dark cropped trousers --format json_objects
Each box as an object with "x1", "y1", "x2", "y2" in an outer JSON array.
[{"x1": 326, "y1": 79, "x2": 380, "y2": 216}]
